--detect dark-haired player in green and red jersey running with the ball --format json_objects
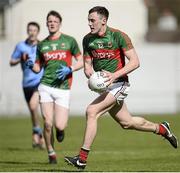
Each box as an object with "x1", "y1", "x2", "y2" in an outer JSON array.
[{"x1": 65, "y1": 6, "x2": 178, "y2": 169}]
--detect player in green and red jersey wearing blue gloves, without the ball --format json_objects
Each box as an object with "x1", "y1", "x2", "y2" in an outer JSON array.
[{"x1": 26, "y1": 11, "x2": 83, "y2": 163}]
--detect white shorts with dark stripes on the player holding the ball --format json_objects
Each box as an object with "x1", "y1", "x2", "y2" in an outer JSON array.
[{"x1": 106, "y1": 82, "x2": 130, "y2": 103}]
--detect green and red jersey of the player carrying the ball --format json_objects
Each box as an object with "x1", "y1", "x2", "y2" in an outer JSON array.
[{"x1": 83, "y1": 27, "x2": 133, "y2": 81}]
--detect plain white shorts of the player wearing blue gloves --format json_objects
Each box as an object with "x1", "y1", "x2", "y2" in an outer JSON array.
[{"x1": 38, "y1": 84, "x2": 70, "y2": 109}]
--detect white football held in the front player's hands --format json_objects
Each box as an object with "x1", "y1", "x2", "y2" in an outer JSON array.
[{"x1": 88, "y1": 71, "x2": 107, "y2": 92}]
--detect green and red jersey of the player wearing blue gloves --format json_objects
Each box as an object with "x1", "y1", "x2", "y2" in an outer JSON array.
[{"x1": 36, "y1": 34, "x2": 81, "y2": 89}]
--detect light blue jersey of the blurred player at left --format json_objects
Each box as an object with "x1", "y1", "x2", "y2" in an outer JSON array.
[{"x1": 11, "y1": 41, "x2": 43, "y2": 88}]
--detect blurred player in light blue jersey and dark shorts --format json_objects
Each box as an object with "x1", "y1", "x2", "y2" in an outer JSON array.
[{"x1": 10, "y1": 22, "x2": 44, "y2": 148}]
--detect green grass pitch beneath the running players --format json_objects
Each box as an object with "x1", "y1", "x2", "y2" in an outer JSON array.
[{"x1": 0, "y1": 115, "x2": 180, "y2": 172}]
